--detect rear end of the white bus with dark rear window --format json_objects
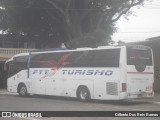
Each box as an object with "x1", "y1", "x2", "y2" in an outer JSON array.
[{"x1": 126, "y1": 46, "x2": 154, "y2": 98}]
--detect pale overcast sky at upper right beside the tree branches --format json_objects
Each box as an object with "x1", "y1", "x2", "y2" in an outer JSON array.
[{"x1": 112, "y1": 0, "x2": 160, "y2": 42}]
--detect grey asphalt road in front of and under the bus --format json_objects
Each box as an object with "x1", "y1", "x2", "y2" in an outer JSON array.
[{"x1": 0, "y1": 95, "x2": 160, "y2": 120}]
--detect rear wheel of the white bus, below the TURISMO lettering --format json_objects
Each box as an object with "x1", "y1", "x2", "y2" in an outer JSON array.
[{"x1": 77, "y1": 86, "x2": 90, "y2": 101}]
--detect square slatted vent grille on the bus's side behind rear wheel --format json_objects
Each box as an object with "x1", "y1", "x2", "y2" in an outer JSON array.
[{"x1": 106, "y1": 82, "x2": 118, "y2": 95}]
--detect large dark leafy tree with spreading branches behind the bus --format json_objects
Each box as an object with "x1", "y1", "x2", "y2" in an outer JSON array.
[{"x1": 0, "y1": 0, "x2": 144, "y2": 48}]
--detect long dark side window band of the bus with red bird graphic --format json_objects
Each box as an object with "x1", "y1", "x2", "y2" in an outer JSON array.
[{"x1": 30, "y1": 49, "x2": 120, "y2": 68}]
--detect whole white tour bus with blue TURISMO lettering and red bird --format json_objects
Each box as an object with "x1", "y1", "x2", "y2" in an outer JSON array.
[{"x1": 6, "y1": 45, "x2": 154, "y2": 101}]
